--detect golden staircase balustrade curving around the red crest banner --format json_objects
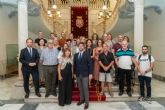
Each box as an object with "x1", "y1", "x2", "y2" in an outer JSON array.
[{"x1": 35, "y1": 0, "x2": 126, "y2": 34}]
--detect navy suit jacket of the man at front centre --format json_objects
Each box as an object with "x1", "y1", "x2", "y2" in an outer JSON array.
[{"x1": 74, "y1": 51, "x2": 92, "y2": 77}]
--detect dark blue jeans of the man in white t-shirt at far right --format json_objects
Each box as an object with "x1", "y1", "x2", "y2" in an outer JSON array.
[{"x1": 138, "y1": 76, "x2": 151, "y2": 97}]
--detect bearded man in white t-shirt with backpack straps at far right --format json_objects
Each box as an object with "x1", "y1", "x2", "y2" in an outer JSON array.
[{"x1": 136, "y1": 45, "x2": 155, "y2": 101}]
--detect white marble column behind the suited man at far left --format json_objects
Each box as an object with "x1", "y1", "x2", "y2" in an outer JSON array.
[{"x1": 18, "y1": 0, "x2": 28, "y2": 84}]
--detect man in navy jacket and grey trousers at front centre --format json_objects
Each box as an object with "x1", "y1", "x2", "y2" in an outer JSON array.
[{"x1": 74, "y1": 42, "x2": 92, "y2": 109}]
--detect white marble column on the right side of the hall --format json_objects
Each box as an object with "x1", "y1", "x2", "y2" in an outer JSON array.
[{"x1": 134, "y1": 0, "x2": 144, "y2": 53}]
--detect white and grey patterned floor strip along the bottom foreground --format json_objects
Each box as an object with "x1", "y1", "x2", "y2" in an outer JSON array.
[{"x1": 0, "y1": 100, "x2": 165, "y2": 110}]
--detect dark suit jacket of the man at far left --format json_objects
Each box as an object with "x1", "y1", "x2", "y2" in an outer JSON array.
[{"x1": 19, "y1": 48, "x2": 39, "y2": 73}]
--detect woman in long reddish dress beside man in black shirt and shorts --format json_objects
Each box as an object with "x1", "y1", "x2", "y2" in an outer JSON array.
[{"x1": 93, "y1": 39, "x2": 103, "y2": 85}]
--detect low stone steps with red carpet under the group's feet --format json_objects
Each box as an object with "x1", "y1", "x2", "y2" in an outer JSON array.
[{"x1": 24, "y1": 85, "x2": 139, "y2": 103}]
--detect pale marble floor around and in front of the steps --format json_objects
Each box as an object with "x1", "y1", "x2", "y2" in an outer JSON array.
[{"x1": 0, "y1": 76, "x2": 165, "y2": 110}]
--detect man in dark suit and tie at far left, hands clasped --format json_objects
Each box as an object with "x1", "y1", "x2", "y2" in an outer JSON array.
[{"x1": 19, "y1": 38, "x2": 41, "y2": 98}]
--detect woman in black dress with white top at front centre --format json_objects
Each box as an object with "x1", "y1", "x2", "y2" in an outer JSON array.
[{"x1": 58, "y1": 48, "x2": 73, "y2": 106}]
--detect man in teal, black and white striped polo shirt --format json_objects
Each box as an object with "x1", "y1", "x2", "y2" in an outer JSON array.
[{"x1": 115, "y1": 41, "x2": 137, "y2": 97}]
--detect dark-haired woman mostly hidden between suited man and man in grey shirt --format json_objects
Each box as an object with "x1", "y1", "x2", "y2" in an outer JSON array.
[{"x1": 37, "y1": 39, "x2": 45, "y2": 86}]
